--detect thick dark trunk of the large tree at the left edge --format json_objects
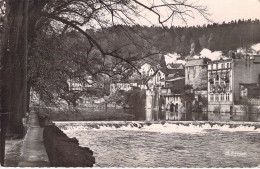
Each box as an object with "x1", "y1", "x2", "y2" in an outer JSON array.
[{"x1": 0, "y1": 0, "x2": 26, "y2": 136}]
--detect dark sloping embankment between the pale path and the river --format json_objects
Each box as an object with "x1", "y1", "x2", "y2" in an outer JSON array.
[{"x1": 43, "y1": 124, "x2": 95, "y2": 167}]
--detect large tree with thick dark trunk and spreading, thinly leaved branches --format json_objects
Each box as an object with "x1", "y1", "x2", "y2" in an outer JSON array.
[{"x1": 0, "y1": 0, "x2": 206, "y2": 135}]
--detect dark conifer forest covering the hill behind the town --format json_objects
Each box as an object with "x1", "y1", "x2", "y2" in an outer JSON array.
[{"x1": 96, "y1": 20, "x2": 260, "y2": 60}]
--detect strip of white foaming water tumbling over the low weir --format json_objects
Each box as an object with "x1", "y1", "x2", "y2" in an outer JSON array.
[{"x1": 55, "y1": 121, "x2": 260, "y2": 134}]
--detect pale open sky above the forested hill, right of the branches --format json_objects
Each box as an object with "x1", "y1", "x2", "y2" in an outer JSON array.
[{"x1": 141, "y1": 0, "x2": 260, "y2": 26}]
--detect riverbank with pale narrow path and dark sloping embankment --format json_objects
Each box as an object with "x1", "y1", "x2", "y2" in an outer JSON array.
[{"x1": 13, "y1": 111, "x2": 95, "y2": 167}]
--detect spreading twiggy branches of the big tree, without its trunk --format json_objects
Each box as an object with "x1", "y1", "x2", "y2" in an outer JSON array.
[{"x1": 19, "y1": 0, "x2": 209, "y2": 105}]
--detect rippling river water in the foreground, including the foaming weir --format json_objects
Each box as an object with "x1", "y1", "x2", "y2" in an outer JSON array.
[{"x1": 56, "y1": 122, "x2": 260, "y2": 167}]
